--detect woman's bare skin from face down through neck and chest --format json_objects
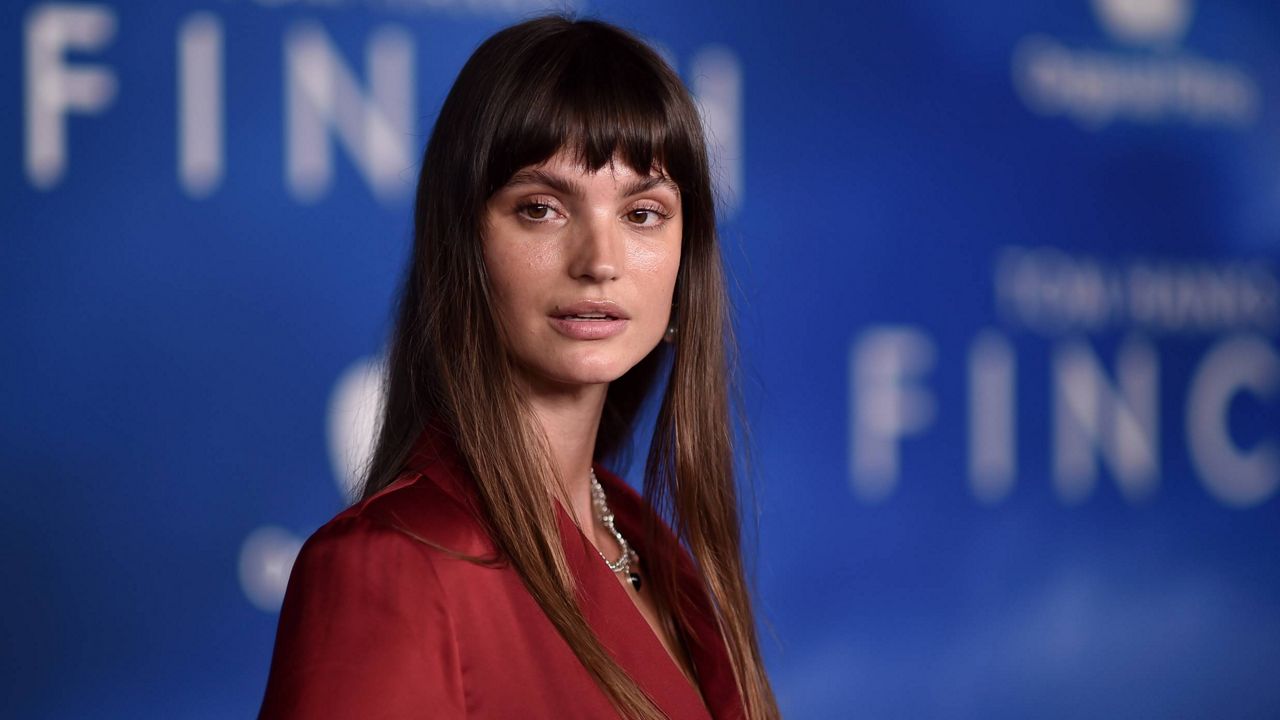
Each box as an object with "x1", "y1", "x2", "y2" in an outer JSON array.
[{"x1": 484, "y1": 151, "x2": 696, "y2": 688}]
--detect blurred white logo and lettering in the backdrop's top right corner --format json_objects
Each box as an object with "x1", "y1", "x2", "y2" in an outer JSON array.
[{"x1": 1012, "y1": 0, "x2": 1262, "y2": 129}]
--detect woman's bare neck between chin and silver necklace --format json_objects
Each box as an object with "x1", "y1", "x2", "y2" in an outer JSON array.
[{"x1": 529, "y1": 371, "x2": 609, "y2": 537}]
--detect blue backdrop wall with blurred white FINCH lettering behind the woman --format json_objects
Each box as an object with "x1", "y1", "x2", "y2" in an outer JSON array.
[{"x1": 0, "y1": 0, "x2": 1280, "y2": 719}]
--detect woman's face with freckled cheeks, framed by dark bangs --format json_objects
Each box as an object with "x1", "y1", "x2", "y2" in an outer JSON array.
[{"x1": 484, "y1": 150, "x2": 682, "y2": 387}]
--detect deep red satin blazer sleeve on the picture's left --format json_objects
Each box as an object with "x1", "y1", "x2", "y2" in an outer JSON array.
[{"x1": 259, "y1": 515, "x2": 466, "y2": 720}]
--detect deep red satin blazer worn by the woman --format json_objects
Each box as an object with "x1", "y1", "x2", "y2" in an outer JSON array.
[{"x1": 260, "y1": 422, "x2": 744, "y2": 720}]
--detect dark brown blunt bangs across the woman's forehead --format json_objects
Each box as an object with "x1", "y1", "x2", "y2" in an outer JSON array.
[{"x1": 484, "y1": 20, "x2": 705, "y2": 196}]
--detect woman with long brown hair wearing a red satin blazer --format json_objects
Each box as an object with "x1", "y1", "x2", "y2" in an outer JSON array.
[{"x1": 261, "y1": 17, "x2": 777, "y2": 720}]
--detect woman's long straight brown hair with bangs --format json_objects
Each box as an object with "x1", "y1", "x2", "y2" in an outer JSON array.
[{"x1": 361, "y1": 15, "x2": 778, "y2": 720}]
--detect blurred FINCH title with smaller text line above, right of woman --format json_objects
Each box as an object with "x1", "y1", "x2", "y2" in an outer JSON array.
[{"x1": 849, "y1": 247, "x2": 1280, "y2": 509}]
